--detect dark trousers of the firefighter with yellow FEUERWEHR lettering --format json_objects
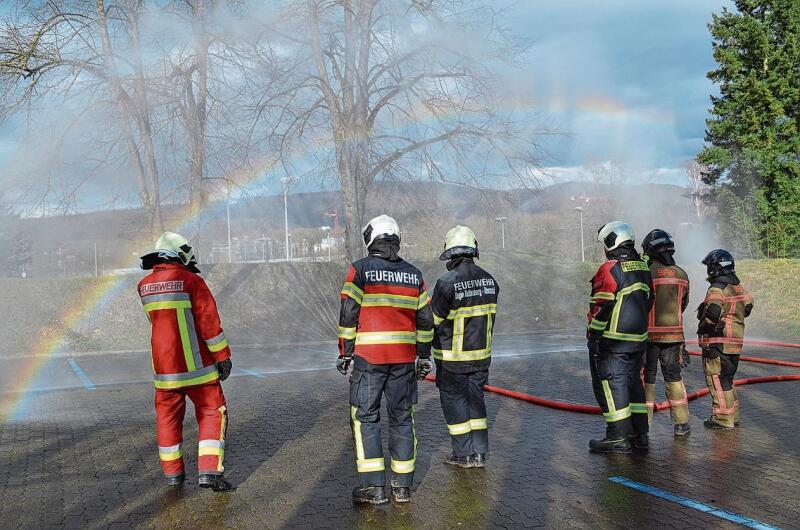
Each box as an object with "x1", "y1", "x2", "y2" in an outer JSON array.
[{"x1": 589, "y1": 344, "x2": 649, "y2": 440}]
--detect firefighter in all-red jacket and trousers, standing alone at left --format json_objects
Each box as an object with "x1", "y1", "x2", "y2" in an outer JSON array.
[{"x1": 139, "y1": 232, "x2": 233, "y2": 491}]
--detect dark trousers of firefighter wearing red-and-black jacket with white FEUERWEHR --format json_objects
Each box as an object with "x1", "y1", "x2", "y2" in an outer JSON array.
[{"x1": 350, "y1": 357, "x2": 417, "y2": 487}]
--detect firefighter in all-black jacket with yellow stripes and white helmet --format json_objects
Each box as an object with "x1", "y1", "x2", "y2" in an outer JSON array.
[{"x1": 431, "y1": 226, "x2": 498, "y2": 467}]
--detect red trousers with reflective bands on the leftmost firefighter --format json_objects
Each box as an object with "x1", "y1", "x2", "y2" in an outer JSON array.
[{"x1": 155, "y1": 381, "x2": 228, "y2": 477}]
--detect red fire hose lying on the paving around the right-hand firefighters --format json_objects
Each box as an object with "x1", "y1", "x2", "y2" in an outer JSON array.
[{"x1": 425, "y1": 340, "x2": 800, "y2": 414}]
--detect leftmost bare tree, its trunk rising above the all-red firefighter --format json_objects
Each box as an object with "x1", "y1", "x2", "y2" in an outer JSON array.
[{"x1": 0, "y1": 0, "x2": 163, "y2": 232}]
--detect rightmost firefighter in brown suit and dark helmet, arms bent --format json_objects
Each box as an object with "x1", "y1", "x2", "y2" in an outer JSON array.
[{"x1": 697, "y1": 249, "x2": 753, "y2": 429}]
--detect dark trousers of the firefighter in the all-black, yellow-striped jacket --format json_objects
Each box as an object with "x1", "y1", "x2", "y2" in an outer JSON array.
[{"x1": 436, "y1": 363, "x2": 489, "y2": 456}]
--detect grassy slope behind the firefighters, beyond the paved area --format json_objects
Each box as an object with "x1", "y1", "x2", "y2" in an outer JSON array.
[{"x1": 0, "y1": 252, "x2": 800, "y2": 354}]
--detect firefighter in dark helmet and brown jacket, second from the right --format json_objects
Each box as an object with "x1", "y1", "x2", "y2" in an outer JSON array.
[{"x1": 642, "y1": 228, "x2": 691, "y2": 436}]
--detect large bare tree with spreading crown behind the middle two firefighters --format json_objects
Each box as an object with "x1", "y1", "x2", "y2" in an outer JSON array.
[{"x1": 247, "y1": 0, "x2": 553, "y2": 258}]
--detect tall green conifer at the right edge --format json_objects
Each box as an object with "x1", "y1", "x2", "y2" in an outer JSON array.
[{"x1": 698, "y1": 0, "x2": 800, "y2": 257}]
